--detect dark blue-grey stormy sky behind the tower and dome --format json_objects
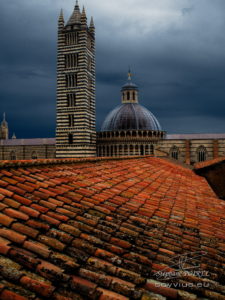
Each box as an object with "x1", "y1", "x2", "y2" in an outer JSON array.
[{"x1": 0, "y1": 0, "x2": 225, "y2": 138}]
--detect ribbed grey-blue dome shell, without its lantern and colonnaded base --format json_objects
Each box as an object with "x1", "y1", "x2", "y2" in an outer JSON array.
[{"x1": 101, "y1": 103, "x2": 162, "y2": 131}]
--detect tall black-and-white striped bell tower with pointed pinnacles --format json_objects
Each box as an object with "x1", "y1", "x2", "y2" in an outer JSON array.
[{"x1": 56, "y1": 1, "x2": 96, "y2": 158}]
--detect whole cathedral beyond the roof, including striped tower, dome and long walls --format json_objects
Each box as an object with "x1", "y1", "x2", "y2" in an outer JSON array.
[{"x1": 0, "y1": 2, "x2": 225, "y2": 164}]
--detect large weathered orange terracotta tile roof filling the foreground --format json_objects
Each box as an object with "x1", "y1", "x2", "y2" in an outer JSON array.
[{"x1": 0, "y1": 157, "x2": 225, "y2": 300}]
